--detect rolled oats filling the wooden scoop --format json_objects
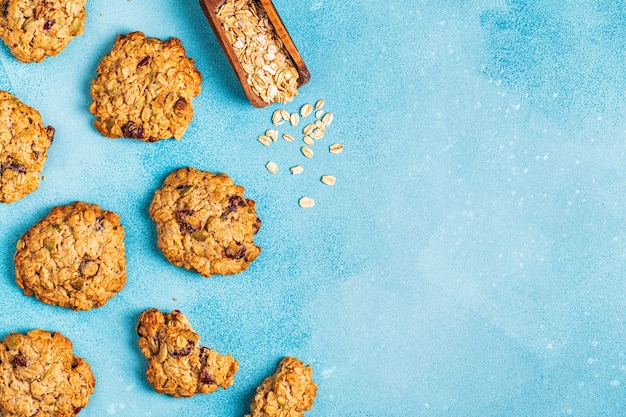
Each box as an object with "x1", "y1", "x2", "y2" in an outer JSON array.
[{"x1": 217, "y1": 0, "x2": 298, "y2": 103}]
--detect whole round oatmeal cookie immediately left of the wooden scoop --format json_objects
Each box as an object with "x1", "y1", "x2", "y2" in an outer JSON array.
[{"x1": 89, "y1": 32, "x2": 202, "y2": 142}]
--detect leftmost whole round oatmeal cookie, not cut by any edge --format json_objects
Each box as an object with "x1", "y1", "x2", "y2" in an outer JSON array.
[{"x1": 14, "y1": 201, "x2": 126, "y2": 310}]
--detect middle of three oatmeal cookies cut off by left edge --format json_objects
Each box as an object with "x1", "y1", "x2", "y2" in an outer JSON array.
[{"x1": 0, "y1": 91, "x2": 54, "y2": 203}]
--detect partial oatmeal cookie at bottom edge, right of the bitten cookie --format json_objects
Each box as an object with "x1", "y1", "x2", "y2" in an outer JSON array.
[{"x1": 246, "y1": 357, "x2": 317, "y2": 417}]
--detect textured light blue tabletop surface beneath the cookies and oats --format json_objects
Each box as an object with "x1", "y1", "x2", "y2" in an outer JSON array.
[{"x1": 0, "y1": 0, "x2": 626, "y2": 417}]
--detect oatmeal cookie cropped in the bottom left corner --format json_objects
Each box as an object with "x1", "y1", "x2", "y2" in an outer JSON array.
[{"x1": 0, "y1": 330, "x2": 96, "y2": 417}]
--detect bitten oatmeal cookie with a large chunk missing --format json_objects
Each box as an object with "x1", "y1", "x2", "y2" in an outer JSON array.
[{"x1": 137, "y1": 308, "x2": 239, "y2": 397}]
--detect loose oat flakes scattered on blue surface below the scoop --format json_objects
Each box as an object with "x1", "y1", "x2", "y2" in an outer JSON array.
[{"x1": 258, "y1": 100, "x2": 343, "y2": 208}]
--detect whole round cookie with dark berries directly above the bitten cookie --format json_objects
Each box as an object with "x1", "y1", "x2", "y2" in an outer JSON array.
[{"x1": 150, "y1": 167, "x2": 261, "y2": 277}]
